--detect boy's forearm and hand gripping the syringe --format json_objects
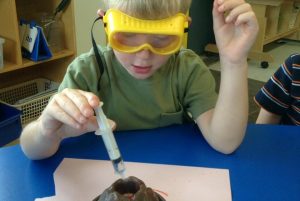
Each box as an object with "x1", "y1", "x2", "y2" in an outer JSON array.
[{"x1": 20, "y1": 89, "x2": 99, "y2": 159}]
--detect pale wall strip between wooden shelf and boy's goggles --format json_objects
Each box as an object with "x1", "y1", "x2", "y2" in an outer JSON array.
[{"x1": 74, "y1": 0, "x2": 105, "y2": 55}]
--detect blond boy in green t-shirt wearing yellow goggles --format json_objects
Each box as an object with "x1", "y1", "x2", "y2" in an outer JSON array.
[{"x1": 21, "y1": 0, "x2": 258, "y2": 159}]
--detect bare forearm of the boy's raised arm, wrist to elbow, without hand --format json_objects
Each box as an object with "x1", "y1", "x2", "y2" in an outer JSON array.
[{"x1": 197, "y1": 59, "x2": 248, "y2": 154}]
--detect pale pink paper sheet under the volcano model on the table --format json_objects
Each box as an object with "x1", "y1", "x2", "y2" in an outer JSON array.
[{"x1": 36, "y1": 158, "x2": 232, "y2": 201}]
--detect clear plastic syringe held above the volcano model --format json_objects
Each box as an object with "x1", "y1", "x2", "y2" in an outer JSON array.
[{"x1": 95, "y1": 102, "x2": 125, "y2": 178}]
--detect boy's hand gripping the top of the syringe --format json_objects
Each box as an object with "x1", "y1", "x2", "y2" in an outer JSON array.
[{"x1": 38, "y1": 89, "x2": 100, "y2": 138}]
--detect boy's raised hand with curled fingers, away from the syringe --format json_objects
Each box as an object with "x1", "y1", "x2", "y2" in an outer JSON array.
[{"x1": 213, "y1": 0, "x2": 258, "y2": 63}]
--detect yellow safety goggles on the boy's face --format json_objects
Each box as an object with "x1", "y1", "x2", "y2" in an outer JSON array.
[{"x1": 103, "y1": 9, "x2": 188, "y2": 55}]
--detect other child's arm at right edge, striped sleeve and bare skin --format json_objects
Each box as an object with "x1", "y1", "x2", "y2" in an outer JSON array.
[{"x1": 254, "y1": 53, "x2": 300, "y2": 124}]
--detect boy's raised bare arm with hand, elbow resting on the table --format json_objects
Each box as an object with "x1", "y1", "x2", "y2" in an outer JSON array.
[{"x1": 197, "y1": 0, "x2": 258, "y2": 153}]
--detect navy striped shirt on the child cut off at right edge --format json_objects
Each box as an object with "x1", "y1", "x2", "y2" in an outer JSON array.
[{"x1": 254, "y1": 54, "x2": 300, "y2": 125}]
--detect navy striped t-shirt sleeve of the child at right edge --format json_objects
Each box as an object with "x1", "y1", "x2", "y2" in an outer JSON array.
[{"x1": 254, "y1": 57, "x2": 293, "y2": 115}]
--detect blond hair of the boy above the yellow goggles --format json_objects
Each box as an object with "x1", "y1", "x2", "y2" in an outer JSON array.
[{"x1": 105, "y1": 0, "x2": 192, "y2": 19}]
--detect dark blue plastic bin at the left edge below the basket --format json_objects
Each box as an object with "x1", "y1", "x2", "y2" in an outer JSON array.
[{"x1": 0, "y1": 103, "x2": 22, "y2": 147}]
